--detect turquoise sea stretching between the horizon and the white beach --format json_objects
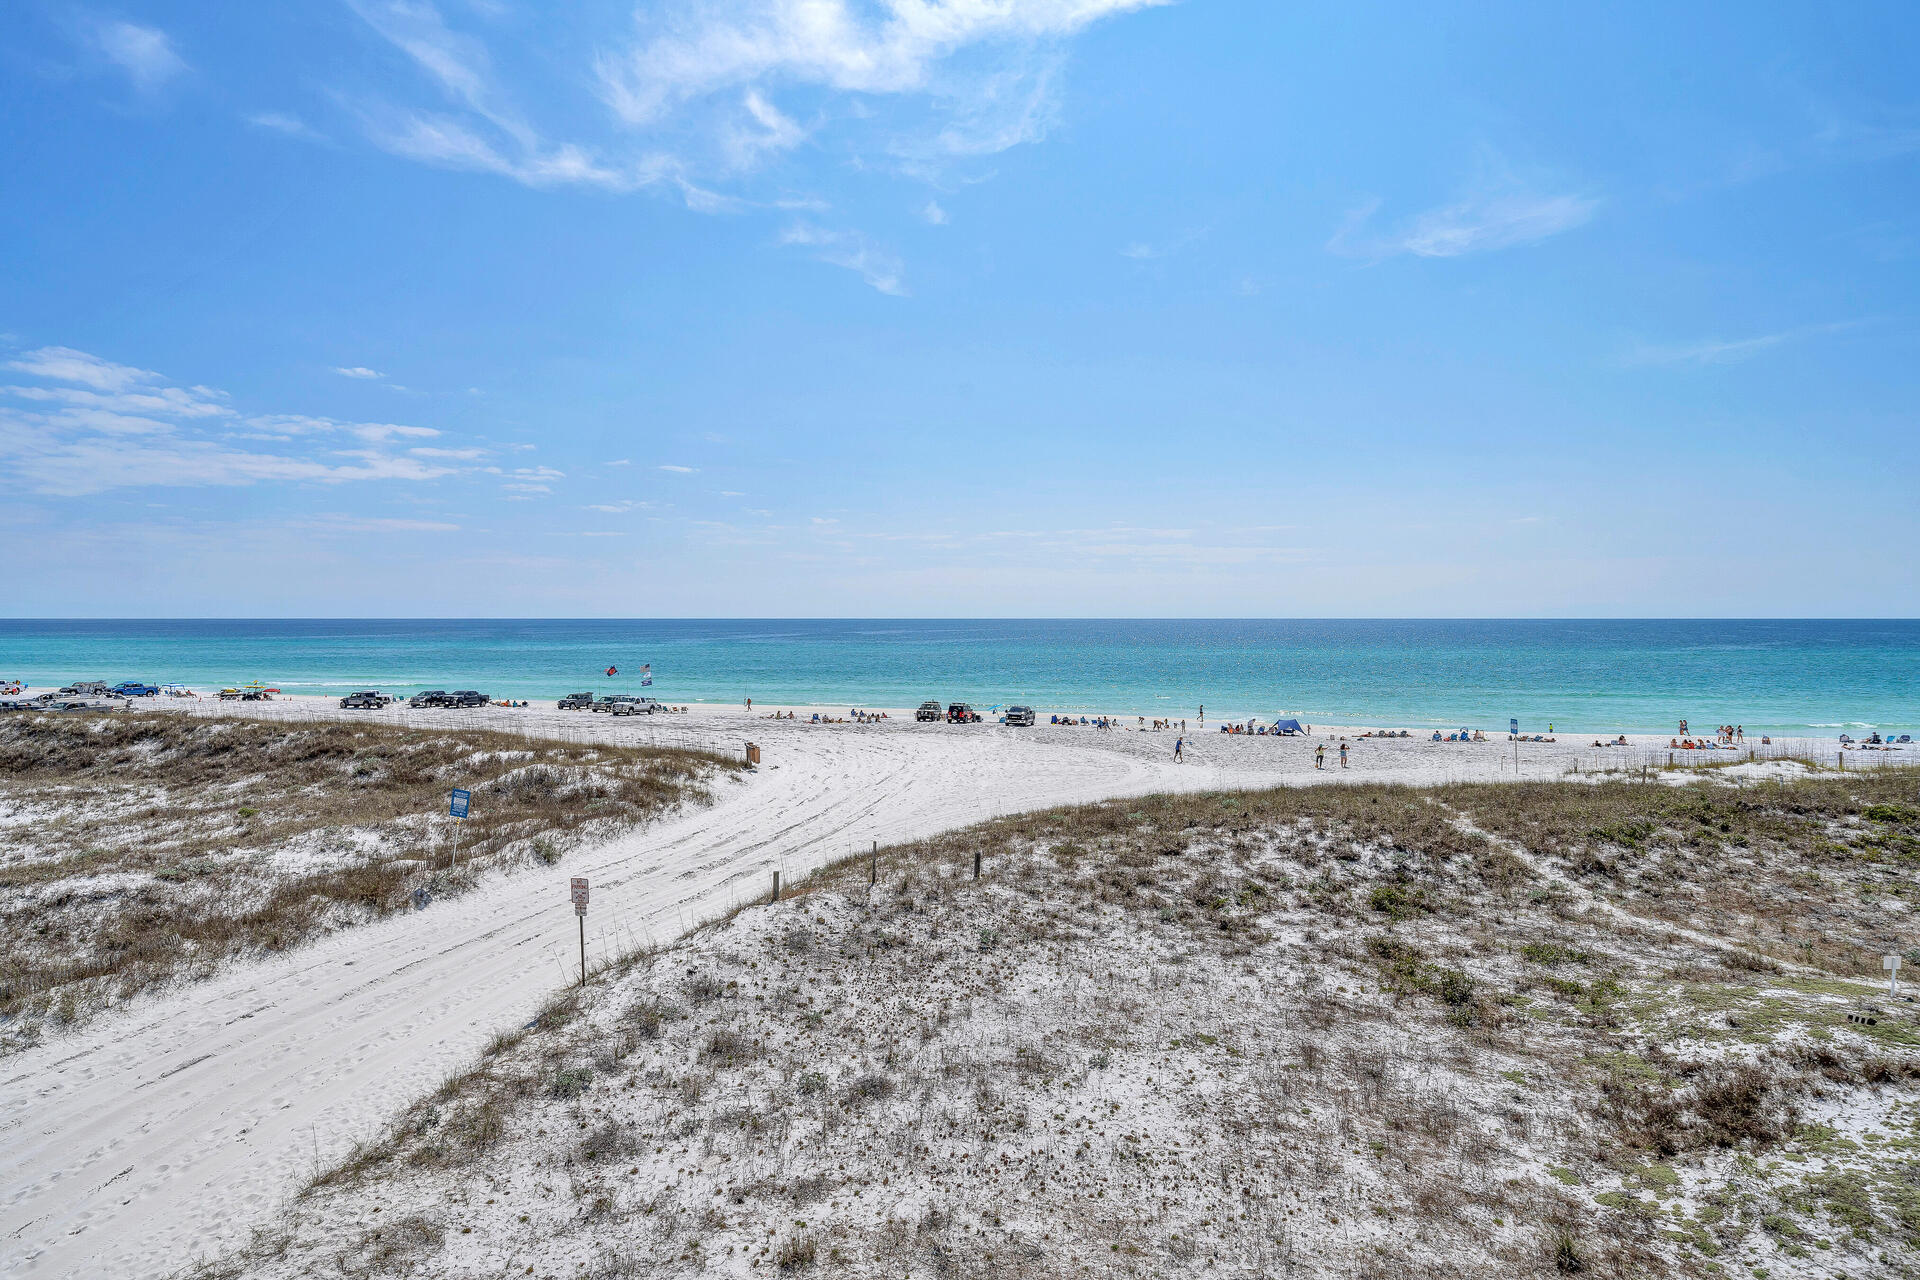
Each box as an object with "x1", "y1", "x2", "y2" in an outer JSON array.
[{"x1": 0, "y1": 620, "x2": 1920, "y2": 735}]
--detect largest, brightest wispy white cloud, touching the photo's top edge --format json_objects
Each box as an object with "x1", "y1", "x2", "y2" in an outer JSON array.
[{"x1": 318, "y1": 0, "x2": 1169, "y2": 201}]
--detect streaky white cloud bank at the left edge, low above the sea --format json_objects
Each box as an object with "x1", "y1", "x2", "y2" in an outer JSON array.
[{"x1": 0, "y1": 347, "x2": 464, "y2": 497}]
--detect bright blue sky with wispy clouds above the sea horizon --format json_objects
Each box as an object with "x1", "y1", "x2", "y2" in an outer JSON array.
[{"x1": 0, "y1": 0, "x2": 1920, "y2": 616}]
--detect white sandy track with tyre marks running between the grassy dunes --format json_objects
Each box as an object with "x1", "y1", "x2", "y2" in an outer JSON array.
[{"x1": 0, "y1": 717, "x2": 1250, "y2": 1278}]
